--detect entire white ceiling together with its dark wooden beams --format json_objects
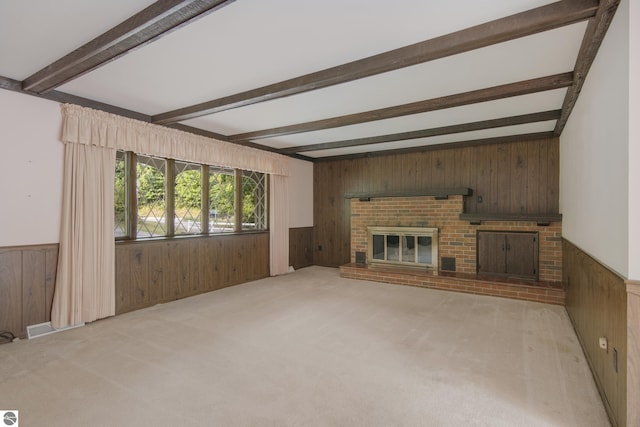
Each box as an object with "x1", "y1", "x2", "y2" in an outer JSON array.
[{"x1": 0, "y1": 0, "x2": 619, "y2": 160}]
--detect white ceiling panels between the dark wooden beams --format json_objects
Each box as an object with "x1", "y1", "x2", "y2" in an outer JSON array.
[{"x1": 0, "y1": 0, "x2": 608, "y2": 158}]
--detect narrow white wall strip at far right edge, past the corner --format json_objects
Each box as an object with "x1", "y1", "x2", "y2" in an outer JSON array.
[{"x1": 628, "y1": 1, "x2": 640, "y2": 280}]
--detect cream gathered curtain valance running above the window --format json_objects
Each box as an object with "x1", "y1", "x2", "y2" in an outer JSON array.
[{"x1": 62, "y1": 104, "x2": 289, "y2": 176}]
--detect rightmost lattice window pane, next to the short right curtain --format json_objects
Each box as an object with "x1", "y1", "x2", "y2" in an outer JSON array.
[{"x1": 242, "y1": 171, "x2": 268, "y2": 230}]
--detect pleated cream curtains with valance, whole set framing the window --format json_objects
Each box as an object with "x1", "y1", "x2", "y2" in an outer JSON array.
[{"x1": 51, "y1": 104, "x2": 290, "y2": 328}]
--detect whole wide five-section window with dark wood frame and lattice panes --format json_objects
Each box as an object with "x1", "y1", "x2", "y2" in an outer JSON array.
[{"x1": 114, "y1": 151, "x2": 268, "y2": 240}]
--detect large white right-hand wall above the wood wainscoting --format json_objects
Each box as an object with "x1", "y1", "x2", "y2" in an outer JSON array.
[{"x1": 560, "y1": 0, "x2": 640, "y2": 278}]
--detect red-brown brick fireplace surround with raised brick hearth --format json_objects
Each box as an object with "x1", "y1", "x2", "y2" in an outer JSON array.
[{"x1": 341, "y1": 195, "x2": 564, "y2": 304}]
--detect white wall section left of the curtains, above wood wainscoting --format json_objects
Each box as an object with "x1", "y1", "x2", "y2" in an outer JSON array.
[{"x1": 0, "y1": 90, "x2": 63, "y2": 247}]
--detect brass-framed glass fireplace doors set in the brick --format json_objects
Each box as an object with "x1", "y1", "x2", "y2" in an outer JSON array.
[{"x1": 367, "y1": 226, "x2": 438, "y2": 270}]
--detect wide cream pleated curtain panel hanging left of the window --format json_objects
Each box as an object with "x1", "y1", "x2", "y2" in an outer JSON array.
[{"x1": 51, "y1": 144, "x2": 116, "y2": 328}]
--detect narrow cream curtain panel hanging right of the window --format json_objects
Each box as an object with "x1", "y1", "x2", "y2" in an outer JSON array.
[{"x1": 269, "y1": 175, "x2": 289, "y2": 276}]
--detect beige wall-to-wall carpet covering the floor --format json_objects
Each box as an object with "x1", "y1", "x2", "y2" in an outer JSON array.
[{"x1": 0, "y1": 267, "x2": 609, "y2": 427}]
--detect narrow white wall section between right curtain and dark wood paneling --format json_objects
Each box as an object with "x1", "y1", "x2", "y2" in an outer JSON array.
[{"x1": 289, "y1": 159, "x2": 313, "y2": 228}]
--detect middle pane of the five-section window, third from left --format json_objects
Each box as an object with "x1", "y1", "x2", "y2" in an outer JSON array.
[{"x1": 173, "y1": 162, "x2": 202, "y2": 235}]
